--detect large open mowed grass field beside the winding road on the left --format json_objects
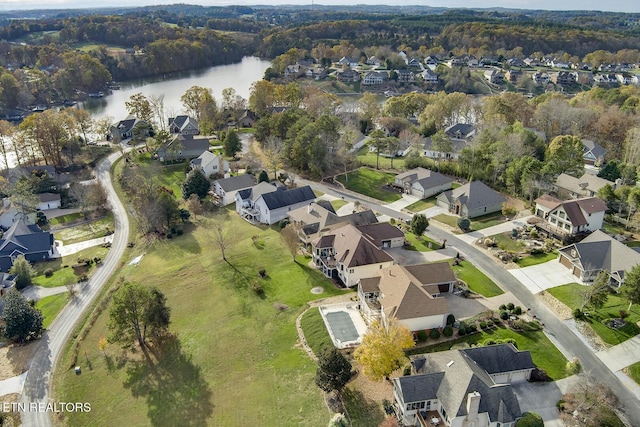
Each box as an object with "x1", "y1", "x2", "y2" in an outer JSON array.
[{"x1": 54, "y1": 213, "x2": 352, "y2": 426}]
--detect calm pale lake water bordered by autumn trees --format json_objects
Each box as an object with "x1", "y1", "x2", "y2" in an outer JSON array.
[{"x1": 79, "y1": 56, "x2": 271, "y2": 121}]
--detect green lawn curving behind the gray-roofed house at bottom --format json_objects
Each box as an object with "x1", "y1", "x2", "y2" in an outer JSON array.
[{"x1": 411, "y1": 326, "x2": 569, "y2": 381}]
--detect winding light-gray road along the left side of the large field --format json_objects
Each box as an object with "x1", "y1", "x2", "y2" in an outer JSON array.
[{"x1": 20, "y1": 152, "x2": 129, "y2": 427}]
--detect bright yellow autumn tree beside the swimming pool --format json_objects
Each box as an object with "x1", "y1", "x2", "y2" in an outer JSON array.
[{"x1": 354, "y1": 319, "x2": 415, "y2": 381}]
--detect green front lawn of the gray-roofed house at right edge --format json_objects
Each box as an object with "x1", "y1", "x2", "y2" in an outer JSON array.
[{"x1": 548, "y1": 283, "x2": 640, "y2": 345}]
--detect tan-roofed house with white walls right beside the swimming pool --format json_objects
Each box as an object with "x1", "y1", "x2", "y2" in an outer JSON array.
[{"x1": 358, "y1": 261, "x2": 456, "y2": 332}]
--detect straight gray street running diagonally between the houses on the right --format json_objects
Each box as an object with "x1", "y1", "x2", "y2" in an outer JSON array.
[{"x1": 297, "y1": 179, "x2": 640, "y2": 426}]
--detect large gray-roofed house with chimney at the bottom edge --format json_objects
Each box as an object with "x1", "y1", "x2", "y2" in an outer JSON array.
[{"x1": 392, "y1": 344, "x2": 535, "y2": 427}]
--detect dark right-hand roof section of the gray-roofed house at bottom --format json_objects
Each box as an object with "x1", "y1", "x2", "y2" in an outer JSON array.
[{"x1": 460, "y1": 344, "x2": 536, "y2": 374}]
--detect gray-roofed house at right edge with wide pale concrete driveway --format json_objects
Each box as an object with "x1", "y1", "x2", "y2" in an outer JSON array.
[{"x1": 558, "y1": 230, "x2": 640, "y2": 290}]
